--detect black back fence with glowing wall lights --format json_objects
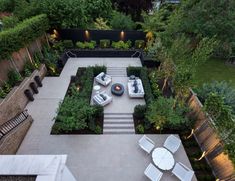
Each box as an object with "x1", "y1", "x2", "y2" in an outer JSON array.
[{"x1": 58, "y1": 29, "x2": 146, "y2": 43}]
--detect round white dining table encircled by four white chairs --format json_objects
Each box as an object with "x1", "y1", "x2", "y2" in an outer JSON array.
[{"x1": 152, "y1": 147, "x2": 175, "y2": 170}]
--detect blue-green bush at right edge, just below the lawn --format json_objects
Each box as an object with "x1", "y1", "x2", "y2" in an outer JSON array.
[{"x1": 196, "y1": 81, "x2": 235, "y2": 113}]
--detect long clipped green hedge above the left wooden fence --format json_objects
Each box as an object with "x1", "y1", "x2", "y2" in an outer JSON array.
[{"x1": 0, "y1": 14, "x2": 49, "y2": 60}]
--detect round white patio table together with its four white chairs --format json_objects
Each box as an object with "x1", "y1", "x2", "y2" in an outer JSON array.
[{"x1": 138, "y1": 135, "x2": 194, "y2": 181}]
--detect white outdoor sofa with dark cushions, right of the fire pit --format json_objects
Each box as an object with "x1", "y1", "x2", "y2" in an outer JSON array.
[{"x1": 127, "y1": 79, "x2": 144, "y2": 98}]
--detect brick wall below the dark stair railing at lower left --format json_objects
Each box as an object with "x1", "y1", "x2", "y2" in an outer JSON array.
[{"x1": 0, "y1": 116, "x2": 33, "y2": 154}]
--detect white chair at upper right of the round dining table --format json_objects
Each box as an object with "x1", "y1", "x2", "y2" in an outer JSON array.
[{"x1": 163, "y1": 135, "x2": 181, "y2": 153}]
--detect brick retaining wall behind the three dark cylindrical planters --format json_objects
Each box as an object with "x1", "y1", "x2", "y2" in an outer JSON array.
[{"x1": 0, "y1": 65, "x2": 47, "y2": 125}]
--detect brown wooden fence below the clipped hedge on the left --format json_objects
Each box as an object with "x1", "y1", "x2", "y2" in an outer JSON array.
[{"x1": 0, "y1": 37, "x2": 45, "y2": 85}]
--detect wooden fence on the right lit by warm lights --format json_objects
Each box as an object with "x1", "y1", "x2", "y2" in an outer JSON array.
[{"x1": 188, "y1": 91, "x2": 235, "y2": 180}]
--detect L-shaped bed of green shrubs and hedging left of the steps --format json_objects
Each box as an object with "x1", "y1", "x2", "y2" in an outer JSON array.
[{"x1": 51, "y1": 66, "x2": 106, "y2": 134}]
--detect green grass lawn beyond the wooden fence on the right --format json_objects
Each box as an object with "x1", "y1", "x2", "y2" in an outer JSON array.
[{"x1": 196, "y1": 59, "x2": 235, "y2": 88}]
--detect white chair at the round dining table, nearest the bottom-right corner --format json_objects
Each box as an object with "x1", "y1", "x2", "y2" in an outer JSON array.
[{"x1": 172, "y1": 162, "x2": 194, "y2": 181}]
